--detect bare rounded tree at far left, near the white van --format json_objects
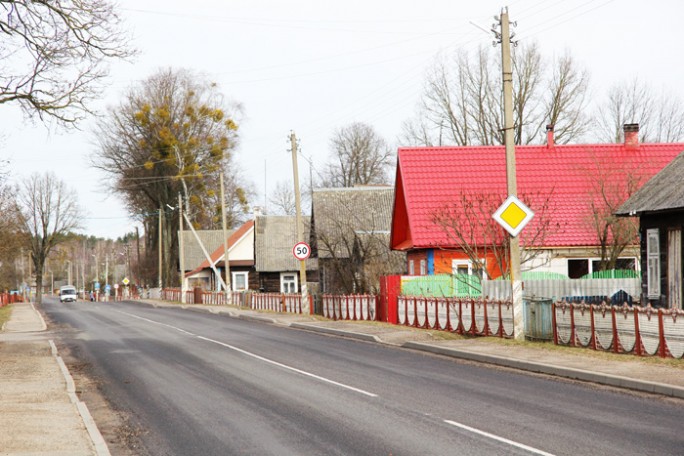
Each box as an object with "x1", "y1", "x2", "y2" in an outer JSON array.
[{"x1": 18, "y1": 173, "x2": 82, "y2": 303}]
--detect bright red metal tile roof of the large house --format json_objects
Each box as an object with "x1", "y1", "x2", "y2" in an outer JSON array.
[{"x1": 390, "y1": 143, "x2": 684, "y2": 250}]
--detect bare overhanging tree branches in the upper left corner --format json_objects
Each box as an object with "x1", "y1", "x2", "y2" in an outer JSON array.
[{"x1": 0, "y1": 0, "x2": 132, "y2": 125}]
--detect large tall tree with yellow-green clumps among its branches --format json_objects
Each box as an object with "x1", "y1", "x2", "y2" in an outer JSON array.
[{"x1": 93, "y1": 69, "x2": 248, "y2": 284}]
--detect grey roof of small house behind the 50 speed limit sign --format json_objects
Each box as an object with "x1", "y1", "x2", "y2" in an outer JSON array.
[{"x1": 254, "y1": 215, "x2": 316, "y2": 272}]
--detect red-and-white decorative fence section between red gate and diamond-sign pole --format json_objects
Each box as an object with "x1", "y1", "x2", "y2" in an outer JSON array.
[{"x1": 398, "y1": 296, "x2": 513, "y2": 337}]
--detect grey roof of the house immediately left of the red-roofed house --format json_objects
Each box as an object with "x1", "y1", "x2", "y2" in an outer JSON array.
[{"x1": 313, "y1": 187, "x2": 394, "y2": 258}]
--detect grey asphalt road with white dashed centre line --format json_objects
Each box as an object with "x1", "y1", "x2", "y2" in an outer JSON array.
[{"x1": 43, "y1": 299, "x2": 684, "y2": 456}]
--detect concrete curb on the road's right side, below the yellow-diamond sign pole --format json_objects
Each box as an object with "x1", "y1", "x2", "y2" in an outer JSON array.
[{"x1": 402, "y1": 342, "x2": 684, "y2": 399}]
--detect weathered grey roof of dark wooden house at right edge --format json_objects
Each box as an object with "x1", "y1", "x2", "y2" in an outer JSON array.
[{"x1": 616, "y1": 153, "x2": 684, "y2": 215}]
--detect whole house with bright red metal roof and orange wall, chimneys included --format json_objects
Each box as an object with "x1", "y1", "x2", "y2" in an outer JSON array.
[{"x1": 390, "y1": 124, "x2": 684, "y2": 278}]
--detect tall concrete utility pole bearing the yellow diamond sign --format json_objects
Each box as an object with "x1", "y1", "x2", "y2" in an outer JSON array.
[{"x1": 499, "y1": 9, "x2": 525, "y2": 340}]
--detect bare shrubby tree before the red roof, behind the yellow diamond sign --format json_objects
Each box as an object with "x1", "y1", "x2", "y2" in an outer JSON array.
[{"x1": 431, "y1": 190, "x2": 565, "y2": 286}]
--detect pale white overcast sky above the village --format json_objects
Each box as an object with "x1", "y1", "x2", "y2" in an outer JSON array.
[{"x1": 0, "y1": 0, "x2": 684, "y2": 239}]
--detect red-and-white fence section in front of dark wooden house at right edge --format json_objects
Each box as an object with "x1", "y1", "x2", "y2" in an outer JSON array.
[{"x1": 553, "y1": 302, "x2": 684, "y2": 359}]
